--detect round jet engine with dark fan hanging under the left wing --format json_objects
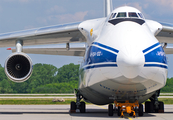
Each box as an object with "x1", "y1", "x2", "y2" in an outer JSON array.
[{"x1": 5, "y1": 52, "x2": 33, "y2": 82}]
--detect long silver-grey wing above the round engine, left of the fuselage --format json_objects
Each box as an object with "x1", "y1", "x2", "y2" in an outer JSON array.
[{"x1": 0, "y1": 22, "x2": 86, "y2": 47}]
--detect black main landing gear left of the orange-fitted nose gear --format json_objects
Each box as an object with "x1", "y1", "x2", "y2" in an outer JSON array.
[{"x1": 70, "y1": 91, "x2": 86, "y2": 113}]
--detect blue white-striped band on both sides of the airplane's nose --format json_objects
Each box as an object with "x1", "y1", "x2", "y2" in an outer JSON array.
[{"x1": 84, "y1": 42, "x2": 168, "y2": 69}]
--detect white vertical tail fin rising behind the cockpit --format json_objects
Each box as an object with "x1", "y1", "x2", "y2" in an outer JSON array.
[{"x1": 104, "y1": 0, "x2": 113, "y2": 17}]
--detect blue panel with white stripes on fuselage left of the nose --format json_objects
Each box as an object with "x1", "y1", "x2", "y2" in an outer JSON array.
[{"x1": 84, "y1": 42, "x2": 119, "y2": 69}]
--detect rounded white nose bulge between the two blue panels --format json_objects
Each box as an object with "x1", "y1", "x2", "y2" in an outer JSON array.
[{"x1": 117, "y1": 51, "x2": 145, "y2": 79}]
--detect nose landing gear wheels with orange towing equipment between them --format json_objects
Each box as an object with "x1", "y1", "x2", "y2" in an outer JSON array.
[{"x1": 108, "y1": 100, "x2": 143, "y2": 117}]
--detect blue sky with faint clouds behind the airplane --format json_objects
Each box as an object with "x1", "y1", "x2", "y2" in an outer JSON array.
[{"x1": 0, "y1": 0, "x2": 173, "y2": 77}]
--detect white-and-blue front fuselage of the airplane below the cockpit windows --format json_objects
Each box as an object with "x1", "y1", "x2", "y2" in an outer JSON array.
[{"x1": 79, "y1": 12, "x2": 167, "y2": 104}]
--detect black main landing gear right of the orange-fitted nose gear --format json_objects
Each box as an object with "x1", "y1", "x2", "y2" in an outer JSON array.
[{"x1": 145, "y1": 90, "x2": 164, "y2": 113}]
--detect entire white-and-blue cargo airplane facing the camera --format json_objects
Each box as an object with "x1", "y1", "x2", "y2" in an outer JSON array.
[{"x1": 0, "y1": 0, "x2": 173, "y2": 117}]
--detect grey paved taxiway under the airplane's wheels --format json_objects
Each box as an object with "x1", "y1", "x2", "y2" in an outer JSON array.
[{"x1": 0, "y1": 105, "x2": 173, "y2": 120}]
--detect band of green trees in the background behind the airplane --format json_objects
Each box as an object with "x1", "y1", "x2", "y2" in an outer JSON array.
[{"x1": 0, "y1": 63, "x2": 173, "y2": 93}]
